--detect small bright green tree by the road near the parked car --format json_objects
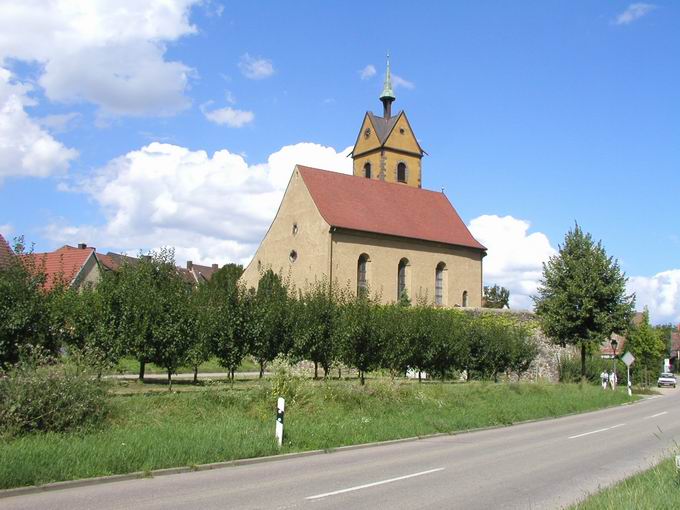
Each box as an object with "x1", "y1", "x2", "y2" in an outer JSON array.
[{"x1": 626, "y1": 308, "x2": 668, "y2": 386}]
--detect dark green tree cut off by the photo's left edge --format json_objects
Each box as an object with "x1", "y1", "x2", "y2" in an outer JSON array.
[{"x1": 0, "y1": 238, "x2": 47, "y2": 368}]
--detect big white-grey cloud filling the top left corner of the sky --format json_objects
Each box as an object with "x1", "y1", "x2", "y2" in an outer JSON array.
[{"x1": 0, "y1": 0, "x2": 198, "y2": 115}]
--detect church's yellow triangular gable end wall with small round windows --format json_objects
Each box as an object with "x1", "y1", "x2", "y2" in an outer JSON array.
[{"x1": 241, "y1": 168, "x2": 330, "y2": 289}]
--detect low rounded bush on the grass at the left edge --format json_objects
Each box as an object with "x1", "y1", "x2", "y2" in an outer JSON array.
[{"x1": 0, "y1": 356, "x2": 109, "y2": 436}]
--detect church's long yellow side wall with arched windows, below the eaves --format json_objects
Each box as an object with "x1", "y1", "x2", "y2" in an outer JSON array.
[{"x1": 332, "y1": 231, "x2": 482, "y2": 307}]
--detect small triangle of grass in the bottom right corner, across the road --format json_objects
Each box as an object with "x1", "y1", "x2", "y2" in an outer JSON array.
[{"x1": 572, "y1": 458, "x2": 680, "y2": 510}]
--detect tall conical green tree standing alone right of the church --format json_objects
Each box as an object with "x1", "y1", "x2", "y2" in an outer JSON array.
[{"x1": 534, "y1": 224, "x2": 635, "y2": 378}]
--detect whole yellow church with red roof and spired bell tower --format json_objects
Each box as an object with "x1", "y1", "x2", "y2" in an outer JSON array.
[{"x1": 242, "y1": 61, "x2": 486, "y2": 307}]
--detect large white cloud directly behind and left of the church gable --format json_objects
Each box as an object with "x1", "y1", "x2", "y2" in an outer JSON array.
[{"x1": 46, "y1": 143, "x2": 352, "y2": 264}]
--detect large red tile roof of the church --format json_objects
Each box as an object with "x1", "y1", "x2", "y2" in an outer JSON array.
[{"x1": 297, "y1": 165, "x2": 486, "y2": 250}]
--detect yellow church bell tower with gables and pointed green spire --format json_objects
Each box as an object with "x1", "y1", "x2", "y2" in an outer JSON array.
[{"x1": 351, "y1": 55, "x2": 425, "y2": 188}]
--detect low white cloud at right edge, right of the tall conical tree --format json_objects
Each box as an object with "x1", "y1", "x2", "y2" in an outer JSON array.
[{"x1": 628, "y1": 269, "x2": 680, "y2": 323}]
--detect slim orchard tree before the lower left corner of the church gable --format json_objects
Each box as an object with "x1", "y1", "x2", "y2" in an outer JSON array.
[{"x1": 249, "y1": 269, "x2": 292, "y2": 377}]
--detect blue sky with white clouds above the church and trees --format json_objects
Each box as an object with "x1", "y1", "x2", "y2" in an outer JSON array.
[{"x1": 0, "y1": 0, "x2": 680, "y2": 323}]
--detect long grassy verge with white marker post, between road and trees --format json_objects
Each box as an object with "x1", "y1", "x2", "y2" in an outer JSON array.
[{"x1": 0, "y1": 377, "x2": 628, "y2": 488}]
